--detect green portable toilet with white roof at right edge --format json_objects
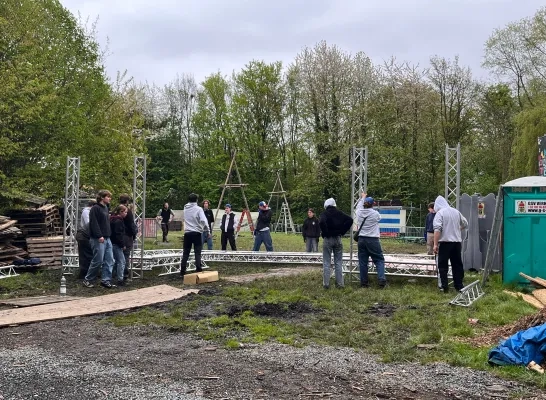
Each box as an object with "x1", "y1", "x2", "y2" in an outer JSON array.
[{"x1": 502, "y1": 176, "x2": 546, "y2": 283}]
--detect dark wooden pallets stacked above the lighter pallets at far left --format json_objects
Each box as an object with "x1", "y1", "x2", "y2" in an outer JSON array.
[{"x1": 8, "y1": 204, "x2": 63, "y2": 237}]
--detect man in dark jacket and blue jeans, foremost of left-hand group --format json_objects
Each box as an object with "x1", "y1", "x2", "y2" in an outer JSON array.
[{"x1": 83, "y1": 190, "x2": 115, "y2": 289}]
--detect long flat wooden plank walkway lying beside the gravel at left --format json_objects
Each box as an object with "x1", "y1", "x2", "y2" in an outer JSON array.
[{"x1": 0, "y1": 285, "x2": 199, "y2": 326}]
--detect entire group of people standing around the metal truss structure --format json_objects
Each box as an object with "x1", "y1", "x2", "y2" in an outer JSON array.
[{"x1": 76, "y1": 190, "x2": 468, "y2": 292}]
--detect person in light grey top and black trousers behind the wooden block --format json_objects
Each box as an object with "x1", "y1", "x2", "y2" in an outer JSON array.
[{"x1": 180, "y1": 193, "x2": 210, "y2": 276}]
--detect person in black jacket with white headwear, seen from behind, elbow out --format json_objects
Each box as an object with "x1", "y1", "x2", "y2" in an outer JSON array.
[{"x1": 319, "y1": 198, "x2": 353, "y2": 289}]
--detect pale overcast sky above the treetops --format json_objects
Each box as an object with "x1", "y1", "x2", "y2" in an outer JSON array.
[{"x1": 61, "y1": 0, "x2": 545, "y2": 85}]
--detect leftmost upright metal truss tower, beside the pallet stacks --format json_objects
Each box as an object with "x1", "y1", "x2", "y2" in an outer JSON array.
[{"x1": 62, "y1": 157, "x2": 80, "y2": 274}]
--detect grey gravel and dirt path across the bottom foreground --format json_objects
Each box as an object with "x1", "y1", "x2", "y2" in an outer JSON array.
[{"x1": 0, "y1": 316, "x2": 546, "y2": 400}]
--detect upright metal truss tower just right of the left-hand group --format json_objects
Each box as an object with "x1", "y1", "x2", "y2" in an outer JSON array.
[{"x1": 132, "y1": 155, "x2": 146, "y2": 279}]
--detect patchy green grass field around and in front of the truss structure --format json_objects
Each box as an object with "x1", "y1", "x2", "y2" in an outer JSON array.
[{"x1": 0, "y1": 234, "x2": 546, "y2": 387}]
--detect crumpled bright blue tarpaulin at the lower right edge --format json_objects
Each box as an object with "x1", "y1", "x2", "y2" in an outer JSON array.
[{"x1": 489, "y1": 324, "x2": 546, "y2": 365}]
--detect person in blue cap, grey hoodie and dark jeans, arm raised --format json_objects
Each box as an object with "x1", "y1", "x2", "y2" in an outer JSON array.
[{"x1": 356, "y1": 193, "x2": 387, "y2": 289}]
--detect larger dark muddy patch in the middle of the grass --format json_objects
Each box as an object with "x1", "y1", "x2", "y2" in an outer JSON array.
[{"x1": 225, "y1": 301, "x2": 321, "y2": 319}]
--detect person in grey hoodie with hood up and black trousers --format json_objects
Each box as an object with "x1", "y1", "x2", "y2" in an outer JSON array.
[{"x1": 433, "y1": 196, "x2": 468, "y2": 293}]
